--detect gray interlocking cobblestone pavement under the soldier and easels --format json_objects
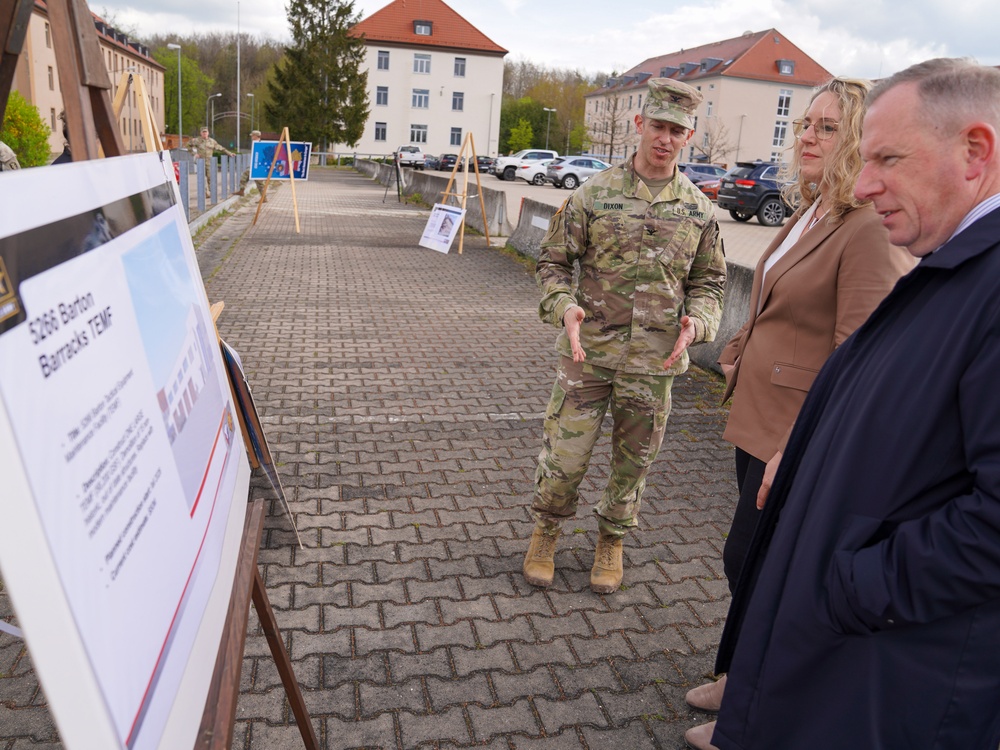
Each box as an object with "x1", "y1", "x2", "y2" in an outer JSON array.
[{"x1": 0, "y1": 169, "x2": 736, "y2": 750}]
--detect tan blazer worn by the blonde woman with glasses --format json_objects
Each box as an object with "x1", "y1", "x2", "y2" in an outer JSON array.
[{"x1": 719, "y1": 206, "x2": 916, "y2": 461}]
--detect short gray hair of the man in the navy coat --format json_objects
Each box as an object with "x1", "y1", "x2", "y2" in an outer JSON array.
[{"x1": 868, "y1": 57, "x2": 1000, "y2": 131}]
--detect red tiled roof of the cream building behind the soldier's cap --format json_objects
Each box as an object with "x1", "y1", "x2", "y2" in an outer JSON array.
[{"x1": 587, "y1": 29, "x2": 832, "y2": 96}]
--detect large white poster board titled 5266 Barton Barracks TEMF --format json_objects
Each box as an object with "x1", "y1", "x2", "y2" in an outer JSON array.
[{"x1": 0, "y1": 154, "x2": 250, "y2": 750}]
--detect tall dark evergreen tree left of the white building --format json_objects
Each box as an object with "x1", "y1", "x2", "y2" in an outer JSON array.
[{"x1": 264, "y1": 0, "x2": 368, "y2": 151}]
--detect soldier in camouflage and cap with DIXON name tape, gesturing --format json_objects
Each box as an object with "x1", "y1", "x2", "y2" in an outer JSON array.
[{"x1": 524, "y1": 78, "x2": 726, "y2": 593}]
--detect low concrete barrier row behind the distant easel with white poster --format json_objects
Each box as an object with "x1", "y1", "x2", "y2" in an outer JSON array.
[{"x1": 354, "y1": 159, "x2": 514, "y2": 237}]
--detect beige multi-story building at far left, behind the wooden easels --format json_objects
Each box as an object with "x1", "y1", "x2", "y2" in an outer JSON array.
[{"x1": 12, "y1": 0, "x2": 164, "y2": 155}]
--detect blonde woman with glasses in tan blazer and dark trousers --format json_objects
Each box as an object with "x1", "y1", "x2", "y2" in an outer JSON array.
[{"x1": 684, "y1": 78, "x2": 914, "y2": 750}]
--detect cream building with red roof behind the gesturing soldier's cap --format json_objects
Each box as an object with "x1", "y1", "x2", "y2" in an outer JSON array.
[{"x1": 585, "y1": 29, "x2": 831, "y2": 164}]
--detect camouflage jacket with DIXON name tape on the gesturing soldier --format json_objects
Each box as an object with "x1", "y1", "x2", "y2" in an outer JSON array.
[{"x1": 535, "y1": 159, "x2": 726, "y2": 375}]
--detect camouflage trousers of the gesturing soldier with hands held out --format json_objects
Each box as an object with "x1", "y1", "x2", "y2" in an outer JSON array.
[{"x1": 531, "y1": 357, "x2": 674, "y2": 537}]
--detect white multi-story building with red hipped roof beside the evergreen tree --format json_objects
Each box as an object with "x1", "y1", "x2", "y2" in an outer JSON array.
[{"x1": 340, "y1": 0, "x2": 507, "y2": 156}]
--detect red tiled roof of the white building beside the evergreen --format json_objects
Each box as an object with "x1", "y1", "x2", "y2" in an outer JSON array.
[{"x1": 351, "y1": 0, "x2": 507, "y2": 55}]
